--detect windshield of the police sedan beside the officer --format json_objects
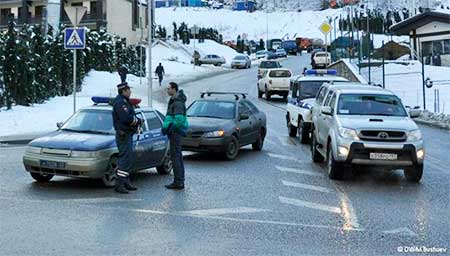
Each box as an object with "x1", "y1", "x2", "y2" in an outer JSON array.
[{"x1": 61, "y1": 109, "x2": 115, "y2": 134}]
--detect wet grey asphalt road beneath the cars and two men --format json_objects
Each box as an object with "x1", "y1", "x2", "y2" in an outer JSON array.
[{"x1": 0, "y1": 56, "x2": 450, "y2": 256}]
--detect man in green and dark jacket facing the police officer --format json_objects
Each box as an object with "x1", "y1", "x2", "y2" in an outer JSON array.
[{"x1": 162, "y1": 82, "x2": 188, "y2": 190}]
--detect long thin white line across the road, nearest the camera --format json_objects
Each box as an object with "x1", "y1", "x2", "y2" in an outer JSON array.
[{"x1": 129, "y1": 209, "x2": 364, "y2": 232}]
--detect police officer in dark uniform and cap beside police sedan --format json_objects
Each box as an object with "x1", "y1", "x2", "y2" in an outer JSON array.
[{"x1": 113, "y1": 82, "x2": 142, "y2": 194}]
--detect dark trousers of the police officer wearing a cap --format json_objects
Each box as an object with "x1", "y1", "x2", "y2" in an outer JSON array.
[{"x1": 116, "y1": 133, "x2": 133, "y2": 184}]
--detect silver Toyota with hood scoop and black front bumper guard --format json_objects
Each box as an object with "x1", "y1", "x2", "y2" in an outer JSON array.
[{"x1": 311, "y1": 82, "x2": 425, "y2": 182}]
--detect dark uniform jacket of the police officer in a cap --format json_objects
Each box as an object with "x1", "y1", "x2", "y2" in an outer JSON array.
[{"x1": 113, "y1": 95, "x2": 139, "y2": 135}]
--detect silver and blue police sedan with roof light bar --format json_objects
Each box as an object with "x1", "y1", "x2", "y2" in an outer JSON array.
[{"x1": 23, "y1": 98, "x2": 172, "y2": 187}]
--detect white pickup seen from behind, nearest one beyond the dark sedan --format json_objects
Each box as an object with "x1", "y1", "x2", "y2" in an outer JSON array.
[{"x1": 258, "y1": 68, "x2": 292, "y2": 100}]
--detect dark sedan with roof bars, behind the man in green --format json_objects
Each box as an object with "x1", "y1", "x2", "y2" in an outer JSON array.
[{"x1": 181, "y1": 92, "x2": 267, "y2": 160}]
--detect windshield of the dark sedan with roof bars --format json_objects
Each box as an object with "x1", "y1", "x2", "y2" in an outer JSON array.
[{"x1": 187, "y1": 101, "x2": 236, "y2": 119}]
